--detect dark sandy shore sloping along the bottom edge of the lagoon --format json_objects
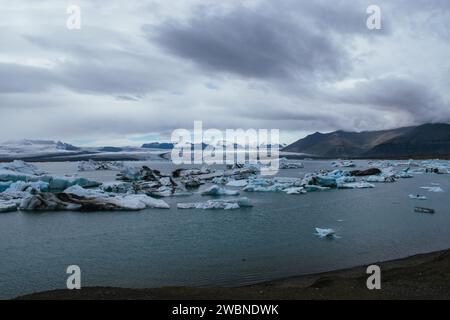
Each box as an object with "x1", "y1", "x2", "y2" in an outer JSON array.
[{"x1": 18, "y1": 249, "x2": 450, "y2": 300}]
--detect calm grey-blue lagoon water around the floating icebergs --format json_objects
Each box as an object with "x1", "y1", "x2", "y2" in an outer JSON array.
[{"x1": 0, "y1": 161, "x2": 450, "y2": 298}]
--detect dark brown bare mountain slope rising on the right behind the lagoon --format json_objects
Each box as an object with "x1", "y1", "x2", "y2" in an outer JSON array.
[{"x1": 282, "y1": 124, "x2": 450, "y2": 158}]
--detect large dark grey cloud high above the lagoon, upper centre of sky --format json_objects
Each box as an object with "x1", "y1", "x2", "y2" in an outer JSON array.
[{"x1": 148, "y1": 4, "x2": 358, "y2": 79}]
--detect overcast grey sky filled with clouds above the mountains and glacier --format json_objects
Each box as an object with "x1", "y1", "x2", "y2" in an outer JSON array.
[{"x1": 0, "y1": 0, "x2": 450, "y2": 145}]
